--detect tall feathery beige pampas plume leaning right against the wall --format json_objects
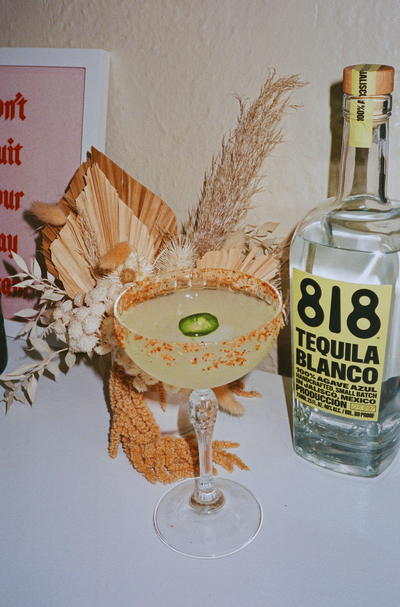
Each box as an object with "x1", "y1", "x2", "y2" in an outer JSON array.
[{"x1": 183, "y1": 71, "x2": 305, "y2": 257}]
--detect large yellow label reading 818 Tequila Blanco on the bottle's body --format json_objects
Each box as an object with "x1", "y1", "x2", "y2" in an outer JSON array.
[{"x1": 292, "y1": 268, "x2": 392, "y2": 421}]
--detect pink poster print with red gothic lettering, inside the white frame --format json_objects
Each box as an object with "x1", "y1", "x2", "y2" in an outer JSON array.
[{"x1": 0, "y1": 66, "x2": 85, "y2": 318}]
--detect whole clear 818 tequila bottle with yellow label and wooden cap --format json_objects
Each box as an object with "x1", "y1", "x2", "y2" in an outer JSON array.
[{"x1": 290, "y1": 64, "x2": 400, "y2": 476}]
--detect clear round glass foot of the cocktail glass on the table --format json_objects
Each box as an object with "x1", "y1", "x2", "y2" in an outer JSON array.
[{"x1": 154, "y1": 478, "x2": 263, "y2": 559}]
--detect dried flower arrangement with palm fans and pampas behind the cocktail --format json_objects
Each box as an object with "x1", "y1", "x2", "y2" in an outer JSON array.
[{"x1": 0, "y1": 72, "x2": 303, "y2": 483}]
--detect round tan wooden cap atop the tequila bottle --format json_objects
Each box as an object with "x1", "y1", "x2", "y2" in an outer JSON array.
[{"x1": 343, "y1": 63, "x2": 394, "y2": 97}]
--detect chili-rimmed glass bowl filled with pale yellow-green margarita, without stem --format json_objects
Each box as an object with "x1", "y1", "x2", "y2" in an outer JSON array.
[{"x1": 113, "y1": 270, "x2": 281, "y2": 389}]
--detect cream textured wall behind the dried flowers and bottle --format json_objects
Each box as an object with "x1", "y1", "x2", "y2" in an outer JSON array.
[{"x1": 0, "y1": 0, "x2": 400, "y2": 241}]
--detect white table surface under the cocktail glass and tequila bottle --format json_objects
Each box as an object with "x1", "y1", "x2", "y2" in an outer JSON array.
[{"x1": 0, "y1": 340, "x2": 400, "y2": 607}]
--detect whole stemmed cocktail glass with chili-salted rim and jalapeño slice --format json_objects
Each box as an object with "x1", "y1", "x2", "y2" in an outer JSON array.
[{"x1": 115, "y1": 269, "x2": 282, "y2": 558}]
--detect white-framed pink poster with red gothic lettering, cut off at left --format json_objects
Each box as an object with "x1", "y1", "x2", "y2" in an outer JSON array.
[{"x1": 0, "y1": 48, "x2": 109, "y2": 330}]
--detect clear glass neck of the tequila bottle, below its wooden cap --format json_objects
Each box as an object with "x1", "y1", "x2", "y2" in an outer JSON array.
[{"x1": 339, "y1": 95, "x2": 392, "y2": 206}]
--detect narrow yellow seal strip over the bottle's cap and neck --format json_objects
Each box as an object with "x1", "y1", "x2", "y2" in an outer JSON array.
[{"x1": 349, "y1": 63, "x2": 380, "y2": 148}]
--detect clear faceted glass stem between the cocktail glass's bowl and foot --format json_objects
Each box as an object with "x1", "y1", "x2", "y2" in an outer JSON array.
[{"x1": 189, "y1": 388, "x2": 225, "y2": 514}]
